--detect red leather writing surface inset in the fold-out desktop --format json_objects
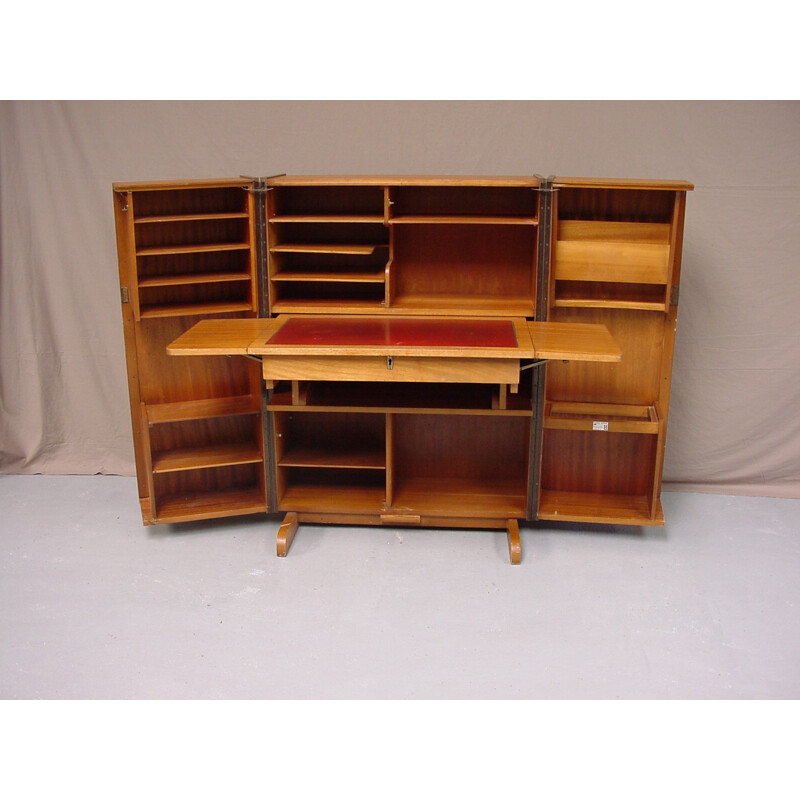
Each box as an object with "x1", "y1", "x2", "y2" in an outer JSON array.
[{"x1": 269, "y1": 317, "x2": 517, "y2": 347}]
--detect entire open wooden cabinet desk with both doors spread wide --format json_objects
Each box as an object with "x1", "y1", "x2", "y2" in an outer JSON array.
[{"x1": 114, "y1": 175, "x2": 693, "y2": 563}]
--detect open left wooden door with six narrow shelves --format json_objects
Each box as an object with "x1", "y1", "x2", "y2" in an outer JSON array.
[{"x1": 113, "y1": 179, "x2": 269, "y2": 525}]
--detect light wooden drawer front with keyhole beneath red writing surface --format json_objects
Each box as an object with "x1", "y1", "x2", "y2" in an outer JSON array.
[{"x1": 262, "y1": 356, "x2": 519, "y2": 384}]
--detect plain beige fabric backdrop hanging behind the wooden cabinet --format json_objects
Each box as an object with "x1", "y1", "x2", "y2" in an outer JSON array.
[{"x1": 0, "y1": 101, "x2": 800, "y2": 497}]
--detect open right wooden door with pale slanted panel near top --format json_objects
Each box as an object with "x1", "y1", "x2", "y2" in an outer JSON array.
[{"x1": 538, "y1": 178, "x2": 692, "y2": 525}]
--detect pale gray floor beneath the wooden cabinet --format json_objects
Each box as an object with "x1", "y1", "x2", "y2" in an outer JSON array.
[{"x1": 0, "y1": 476, "x2": 800, "y2": 699}]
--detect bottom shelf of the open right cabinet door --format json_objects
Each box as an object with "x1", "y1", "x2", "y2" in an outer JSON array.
[{"x1": 538, "y1": 489, "x2": 664, "y2": 525}]
